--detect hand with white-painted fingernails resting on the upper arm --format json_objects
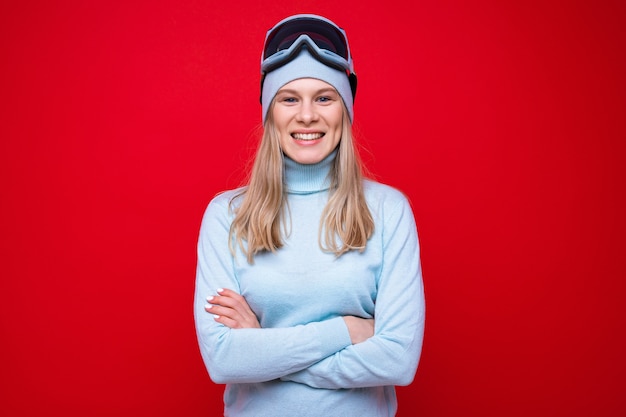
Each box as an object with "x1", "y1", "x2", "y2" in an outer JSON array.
[{"x1": 204, "y1": 288, "x2": 261, "y2": 329}]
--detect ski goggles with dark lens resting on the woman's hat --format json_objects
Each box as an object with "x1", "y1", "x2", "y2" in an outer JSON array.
[{"x1": 261, "y1": 14, "x2": 356, "y2": 95}]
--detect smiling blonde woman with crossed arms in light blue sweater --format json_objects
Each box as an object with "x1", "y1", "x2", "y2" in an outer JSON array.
[{"x1": 194, "y1": 15, "x2": 424, "y2": 417}]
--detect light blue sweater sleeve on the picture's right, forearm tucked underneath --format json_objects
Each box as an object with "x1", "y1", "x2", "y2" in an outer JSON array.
[{"x1": 282, "y1": 197, "x2": 425, "y2": 389}]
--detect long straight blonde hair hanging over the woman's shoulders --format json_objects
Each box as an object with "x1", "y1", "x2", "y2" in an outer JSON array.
[{"x1": 229, "y1": 106, "x2": 374, "y2": 264}]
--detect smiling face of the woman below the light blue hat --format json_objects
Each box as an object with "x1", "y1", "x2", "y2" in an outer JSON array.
[{"x1": 272, "y1": 78, "x2": 343, "y2": 164}]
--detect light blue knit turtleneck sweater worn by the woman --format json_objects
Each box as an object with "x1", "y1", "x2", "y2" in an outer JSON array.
[{"x1": 194, "y1": 153, "x2": 424, "y2": 417}]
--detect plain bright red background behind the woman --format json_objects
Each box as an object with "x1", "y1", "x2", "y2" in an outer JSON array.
[{"x1": 0, "y1": 0, "x2": 626, "y2": 417}]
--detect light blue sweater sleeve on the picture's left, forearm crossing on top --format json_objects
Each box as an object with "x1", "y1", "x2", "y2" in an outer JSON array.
[{"x1": 194, "y1": 195, "x2": 350, "y2": 384}]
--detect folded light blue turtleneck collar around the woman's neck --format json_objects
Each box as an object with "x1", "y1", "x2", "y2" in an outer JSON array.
[{"x1": 284, "y1": 149, "x2": 337, "y2": 194}]
